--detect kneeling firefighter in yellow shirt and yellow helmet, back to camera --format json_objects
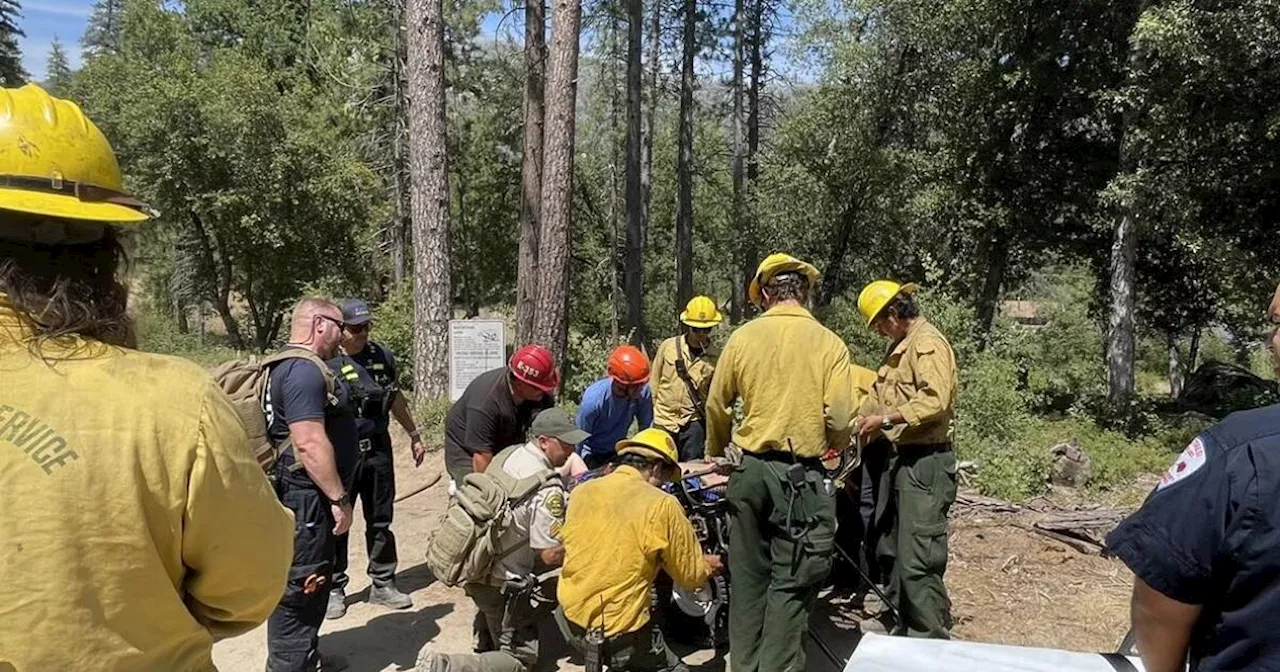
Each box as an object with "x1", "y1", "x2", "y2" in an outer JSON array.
[{"x1": 556, "y1": 429, "x2": 723, "y2": 672}]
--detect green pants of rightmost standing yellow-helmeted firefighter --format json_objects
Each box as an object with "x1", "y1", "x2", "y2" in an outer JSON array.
[{"x1": 875, "y1": 444, "x2": 956, "y2": 639}]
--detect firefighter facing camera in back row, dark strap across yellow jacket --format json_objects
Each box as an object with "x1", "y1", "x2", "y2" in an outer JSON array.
[{"x1": 650, "y1": 296, "x2": 724, "y2": 462}]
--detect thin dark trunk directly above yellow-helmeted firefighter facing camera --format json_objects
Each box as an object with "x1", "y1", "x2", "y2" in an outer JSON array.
[{"x1": 676, "y1": 0, "x2": 698, "y2": 306}]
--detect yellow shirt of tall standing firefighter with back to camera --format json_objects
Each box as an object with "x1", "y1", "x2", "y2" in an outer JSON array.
[{"x1": 707, "y1": 306, "x2": 855, "y2": 457}]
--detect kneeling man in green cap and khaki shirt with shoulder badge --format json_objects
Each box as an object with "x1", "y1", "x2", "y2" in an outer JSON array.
[{"x1": 415, "y1": 408, "x2": 588, "y2": 672}]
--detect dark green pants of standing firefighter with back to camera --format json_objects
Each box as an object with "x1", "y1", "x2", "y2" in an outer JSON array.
[{"x1": 727, "y1": 453, "x2": 836, "y2": 672}]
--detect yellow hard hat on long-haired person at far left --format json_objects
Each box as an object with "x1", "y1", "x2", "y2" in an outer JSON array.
[{"x1": 0, "y1": 84, "x2": 151, "y2": 224}]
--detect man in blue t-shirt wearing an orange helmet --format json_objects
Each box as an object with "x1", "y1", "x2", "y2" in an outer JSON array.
[{"x1": 577, "y1": 346, "x2": 653, "y2": 470}]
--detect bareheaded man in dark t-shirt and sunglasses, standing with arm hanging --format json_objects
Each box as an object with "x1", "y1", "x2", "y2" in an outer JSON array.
[{"x1": 264, "y1": 298, "x2": 358, "y2": 672}]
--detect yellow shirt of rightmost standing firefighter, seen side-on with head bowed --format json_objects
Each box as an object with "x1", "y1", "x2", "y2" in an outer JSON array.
[{"x1": 874, "y1": 317, "x2": 956, "y2": 445}]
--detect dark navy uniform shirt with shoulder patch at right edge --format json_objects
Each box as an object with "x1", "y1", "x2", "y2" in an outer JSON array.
[{"x1": 1107, "y1": 406, "x2": 1280, "y2": 672}]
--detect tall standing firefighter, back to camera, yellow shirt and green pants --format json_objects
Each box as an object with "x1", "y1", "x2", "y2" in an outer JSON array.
[{"x1": 707, "y1": 253, "x2": 854, "y2": 672}]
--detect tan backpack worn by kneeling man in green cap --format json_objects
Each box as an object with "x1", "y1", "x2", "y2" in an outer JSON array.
[{"x1": 426, "y1": 444, "x2": 563, "y2": 586}]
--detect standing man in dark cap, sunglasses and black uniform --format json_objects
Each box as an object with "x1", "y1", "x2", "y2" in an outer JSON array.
[{"x1": 325, "y1": 298, "x2": 426, "y2": 618}]
